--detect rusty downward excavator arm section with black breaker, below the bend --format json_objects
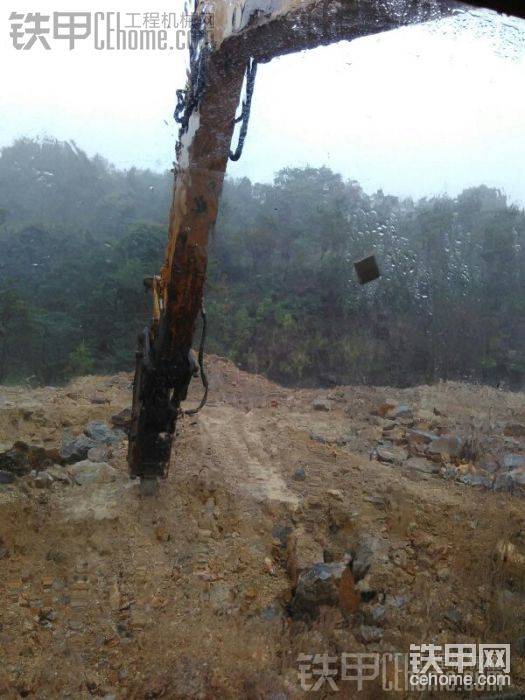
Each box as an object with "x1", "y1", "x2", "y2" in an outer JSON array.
[{"x1": 128, "y1": 46, "x2": 248, "y2": 479}]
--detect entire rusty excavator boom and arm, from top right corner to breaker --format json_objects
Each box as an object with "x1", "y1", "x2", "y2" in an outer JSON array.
[{"x1": 128, "y1": 0, "x2": 525, "y2": 485}]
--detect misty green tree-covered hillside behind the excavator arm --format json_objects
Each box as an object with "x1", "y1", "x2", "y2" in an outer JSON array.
[{"x1": 0, "y1": 139, "x2": 525, "y2": 387}]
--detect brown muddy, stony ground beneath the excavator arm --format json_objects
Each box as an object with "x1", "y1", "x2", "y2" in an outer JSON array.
[{"x1": 0, "y1": 358, "x2": 525, "y2": 700}]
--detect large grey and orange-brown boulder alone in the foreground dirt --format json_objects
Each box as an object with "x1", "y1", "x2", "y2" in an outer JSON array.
[{"x1": 290, "y1": 562, "x2": 360, "y2": 618}]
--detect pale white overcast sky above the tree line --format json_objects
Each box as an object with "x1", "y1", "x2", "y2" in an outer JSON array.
[{"x1": 0, "y1": 0, "x2": 525, "y2": 204}]
